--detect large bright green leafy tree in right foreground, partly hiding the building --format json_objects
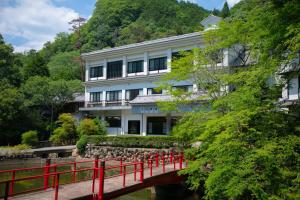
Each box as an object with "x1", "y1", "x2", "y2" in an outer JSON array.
[{"x1": 162, "y1": 0, "x2": 300, "y2": 199}]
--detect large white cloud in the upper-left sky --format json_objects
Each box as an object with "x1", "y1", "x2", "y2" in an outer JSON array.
[{"x1": 0, "y1": 0, "x2": 79, "y2": 52}]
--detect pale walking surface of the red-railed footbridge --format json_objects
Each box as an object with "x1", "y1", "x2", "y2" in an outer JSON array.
[{"x1": 10, "y1": 164, "x2": 182, "y2": 200}]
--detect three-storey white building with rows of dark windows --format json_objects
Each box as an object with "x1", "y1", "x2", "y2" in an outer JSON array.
[{"x1": 80, "y1": 28, "x2": 239, "y2": 136}]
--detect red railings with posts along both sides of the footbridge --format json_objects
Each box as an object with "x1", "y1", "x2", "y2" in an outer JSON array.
[{"x1": 0, "y1": 152, "x2": 187, "y2": 200}]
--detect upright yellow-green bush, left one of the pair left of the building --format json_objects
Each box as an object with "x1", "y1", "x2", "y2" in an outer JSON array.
[{"x1": 50, "y1": 113, "x2": 78, "y2": 145}]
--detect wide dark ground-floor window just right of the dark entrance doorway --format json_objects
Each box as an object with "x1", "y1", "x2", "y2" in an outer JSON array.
[{"x1": 147, "y1": 117, "x2": 167, "y2": 135}]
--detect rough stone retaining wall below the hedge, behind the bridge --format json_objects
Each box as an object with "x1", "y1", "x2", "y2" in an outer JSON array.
[{"x1": 85, "y1": 144, "x2": 178, "y2": 162}]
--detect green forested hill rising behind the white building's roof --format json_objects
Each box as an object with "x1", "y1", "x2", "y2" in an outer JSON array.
[{"x1": 43, "y1": 0, "x2": 209, "y2": 55}]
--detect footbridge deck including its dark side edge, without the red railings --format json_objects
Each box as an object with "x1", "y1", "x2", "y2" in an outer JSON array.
[{"x1": 9, "y1": 164, "x2": 183, "y2": 200}]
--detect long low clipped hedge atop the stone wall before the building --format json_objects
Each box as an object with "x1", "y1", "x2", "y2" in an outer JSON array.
[{"x1": 87, "y1": 135, "x2": 188, "y2": 148}]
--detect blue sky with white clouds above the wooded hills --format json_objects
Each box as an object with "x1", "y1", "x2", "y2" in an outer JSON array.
[{"x1": 0, "y1": 0, "x2": 240, "y2": 52}]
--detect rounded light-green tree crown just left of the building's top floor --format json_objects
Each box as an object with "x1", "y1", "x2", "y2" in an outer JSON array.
[{"x1": 47, "y1": 51, "x2": 80, "y2": 80}]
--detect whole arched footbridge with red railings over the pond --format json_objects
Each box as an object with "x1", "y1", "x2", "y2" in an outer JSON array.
[{"x1": 0, "y1": 153, "x2": 187, "y2": 200}]
